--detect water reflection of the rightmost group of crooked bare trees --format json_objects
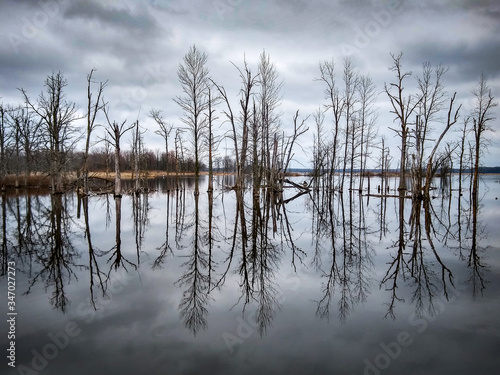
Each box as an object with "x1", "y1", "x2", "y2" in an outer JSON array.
[{"x1": 381, "y1": 184, "x2": 492, "y2": 318}]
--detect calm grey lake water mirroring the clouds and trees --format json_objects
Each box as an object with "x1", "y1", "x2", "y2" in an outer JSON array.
[{"x1": 0, "y1": 175, "x2": 500, "y2": 375}]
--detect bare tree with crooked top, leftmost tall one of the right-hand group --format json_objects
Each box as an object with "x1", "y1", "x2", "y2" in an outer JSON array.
[{"x1": 384, "y1": 53, "x2": 422, "y2": 191}]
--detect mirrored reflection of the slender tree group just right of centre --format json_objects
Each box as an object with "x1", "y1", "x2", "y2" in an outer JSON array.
[{"x1": 313, "y1": 192, "x2": 373, "y2": 322}]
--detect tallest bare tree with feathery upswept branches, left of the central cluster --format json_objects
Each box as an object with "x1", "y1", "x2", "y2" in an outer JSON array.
[{"x1": 174, "y1": 45, "x2": 209, "y2": 176}]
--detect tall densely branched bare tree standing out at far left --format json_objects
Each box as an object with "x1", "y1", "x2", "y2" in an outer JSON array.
[{"x1": 20, "y1": 72, "x2": 78, "y2": 193}]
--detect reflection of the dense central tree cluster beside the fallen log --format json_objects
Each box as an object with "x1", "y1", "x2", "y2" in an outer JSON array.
[{"x1": 216, "y1": 189, "x2": 303, "y2": 335}]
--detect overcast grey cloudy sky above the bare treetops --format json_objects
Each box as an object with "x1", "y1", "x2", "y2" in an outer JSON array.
[{"x1": 0, "y1": 0, "x2": 500, "y2": 168}]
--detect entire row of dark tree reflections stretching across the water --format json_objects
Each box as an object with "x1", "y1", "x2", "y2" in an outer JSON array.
[{"x1": 0, "y1": 173, "x2": 488, "y2": 328}]
